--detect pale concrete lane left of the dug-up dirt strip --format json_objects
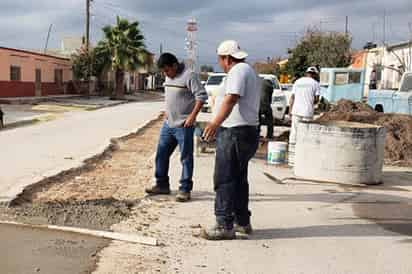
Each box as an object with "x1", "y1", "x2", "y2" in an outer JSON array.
[{"x1": 0, "y1": 102, "x2": 163, "y2": 202}]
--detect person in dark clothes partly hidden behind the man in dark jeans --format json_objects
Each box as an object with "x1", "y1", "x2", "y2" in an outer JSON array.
[{"x1": 259, "y1": 79, "x2": 273, "y2": 139}]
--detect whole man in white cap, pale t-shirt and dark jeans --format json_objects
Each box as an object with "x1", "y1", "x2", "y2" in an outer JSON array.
[{"x1": 201, "y1": 40, "x2": 260, "y2": 240}]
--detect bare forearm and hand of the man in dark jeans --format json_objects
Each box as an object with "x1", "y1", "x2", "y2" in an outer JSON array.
[{"x1": 203, "y1": 94, "x2": 240, "y2": 141}]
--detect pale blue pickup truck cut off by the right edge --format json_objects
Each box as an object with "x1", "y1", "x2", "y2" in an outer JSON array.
[{"x1": 368, "y1": 72, "x2": 412, "y2": 115}]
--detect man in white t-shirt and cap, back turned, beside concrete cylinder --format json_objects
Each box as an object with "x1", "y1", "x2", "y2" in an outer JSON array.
[{"x1": 289, "y1": 67, "x2": 320, "y2": 148}]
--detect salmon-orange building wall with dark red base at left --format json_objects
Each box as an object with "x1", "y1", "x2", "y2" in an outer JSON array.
[{"x1": 0, "y1": 47, "x2": 73, "y2": 97}]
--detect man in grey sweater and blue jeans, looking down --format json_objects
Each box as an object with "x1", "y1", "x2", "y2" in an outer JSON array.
[{"x1": 146, "y1": 53, "x2": 207, "y2": 202}]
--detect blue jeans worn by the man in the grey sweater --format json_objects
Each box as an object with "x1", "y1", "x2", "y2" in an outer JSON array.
[{"x1": 155, "y1": 121, "x2": 195, "y2": 192}]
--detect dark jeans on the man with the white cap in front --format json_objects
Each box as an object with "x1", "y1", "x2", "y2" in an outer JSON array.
[{"x1": 214, "y1": 126, "x2": 259, "y2": 229}]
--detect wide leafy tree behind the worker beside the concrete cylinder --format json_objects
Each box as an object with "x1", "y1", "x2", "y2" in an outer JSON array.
[{"x1": 286, "y1": 29, "x2": 352, "y2": 77}]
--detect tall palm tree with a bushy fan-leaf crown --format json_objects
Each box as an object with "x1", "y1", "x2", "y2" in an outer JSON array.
[{"x1": 96, "y1": 17, "x2": 147, "y2": 99}]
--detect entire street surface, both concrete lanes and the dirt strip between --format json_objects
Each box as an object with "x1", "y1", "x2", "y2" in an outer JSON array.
[{"x1": 0, "y1": 99, "x2": 412, "y2": 274}]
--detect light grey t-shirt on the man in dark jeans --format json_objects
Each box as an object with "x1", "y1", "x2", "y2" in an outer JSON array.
[{"x1": 214, "y1": 63, "x2": 261, "y2": 127}]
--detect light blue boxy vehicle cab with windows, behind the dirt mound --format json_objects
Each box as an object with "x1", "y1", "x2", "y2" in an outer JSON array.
[{"x1": 320, "y1": 68, "x2": 365, "y2": 104}]
